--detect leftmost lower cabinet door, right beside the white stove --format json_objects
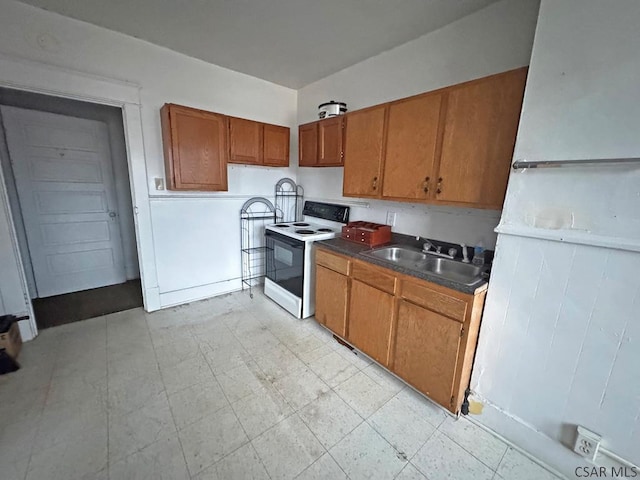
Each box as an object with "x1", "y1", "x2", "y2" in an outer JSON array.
[{"x1": 315, "y1": 265, "x2": 348, "y2": 338}]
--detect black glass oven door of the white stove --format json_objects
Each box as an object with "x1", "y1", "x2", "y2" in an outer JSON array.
[{"x1": 264, "y1": 230, "x2": 304, "y2": 298}]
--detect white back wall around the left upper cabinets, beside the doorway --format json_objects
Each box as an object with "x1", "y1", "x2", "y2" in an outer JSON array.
[{"x1": 0, "y1": 0, "x2": 297, "y2": 312}]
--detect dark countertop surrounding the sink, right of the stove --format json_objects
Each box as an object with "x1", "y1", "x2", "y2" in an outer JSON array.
[{"x1": 316, "y1": 233, "x2": 489, "y2": 295}]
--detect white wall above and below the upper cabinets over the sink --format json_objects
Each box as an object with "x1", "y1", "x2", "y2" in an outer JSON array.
[{"x1": 298, "y1": 0, "x2": 539, "y2": 247}]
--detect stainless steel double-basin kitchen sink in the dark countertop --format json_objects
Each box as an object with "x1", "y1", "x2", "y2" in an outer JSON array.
[{"x1": 362, "y1": 246, "x2": 483, "y2": 285}]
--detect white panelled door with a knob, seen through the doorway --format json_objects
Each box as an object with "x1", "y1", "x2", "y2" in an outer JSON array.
[{"x1": 0, "y1": 106, "x2": 126, "y2": 297}]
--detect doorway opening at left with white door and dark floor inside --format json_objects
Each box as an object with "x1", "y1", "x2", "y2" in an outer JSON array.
[{"x1": 0, "y1": 88, "x2": 142, "y2": 328}]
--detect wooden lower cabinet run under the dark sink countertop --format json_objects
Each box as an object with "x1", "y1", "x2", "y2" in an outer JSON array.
[{"x1": 316, "y1": 247, "x2": 486, "y2": 413}]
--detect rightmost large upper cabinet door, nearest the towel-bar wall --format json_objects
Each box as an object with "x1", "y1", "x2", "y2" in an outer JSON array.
[{"x1": 435, "y1": 68, "x2": 527, "y2": 209}]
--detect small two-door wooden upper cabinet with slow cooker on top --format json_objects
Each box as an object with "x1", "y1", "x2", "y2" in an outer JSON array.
[{"x1": 298, "y1": 115, "x2": 344, "y2": 167}]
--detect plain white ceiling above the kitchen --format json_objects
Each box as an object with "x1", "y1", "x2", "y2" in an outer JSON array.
[{"x1": 21, "y1": 0, "x2": 496, "y2": 89}]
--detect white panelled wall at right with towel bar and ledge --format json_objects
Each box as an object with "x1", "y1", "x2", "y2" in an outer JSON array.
[{"x1": 472, "y1": 0, "x2": 640, "y2": 472}]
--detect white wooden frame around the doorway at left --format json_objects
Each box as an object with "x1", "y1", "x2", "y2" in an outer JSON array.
[{"x1": 0, "y1": 54, "x2": 160, "y2": 340}]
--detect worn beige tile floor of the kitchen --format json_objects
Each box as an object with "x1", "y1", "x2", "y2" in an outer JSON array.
[{"x1": 0, "y1": 292, "x2": 556, "y2": 480}]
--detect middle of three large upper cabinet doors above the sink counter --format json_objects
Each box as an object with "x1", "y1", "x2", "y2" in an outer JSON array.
[{"x1": 382, "y1": 94, "x2": 442, "y2": 200}]
